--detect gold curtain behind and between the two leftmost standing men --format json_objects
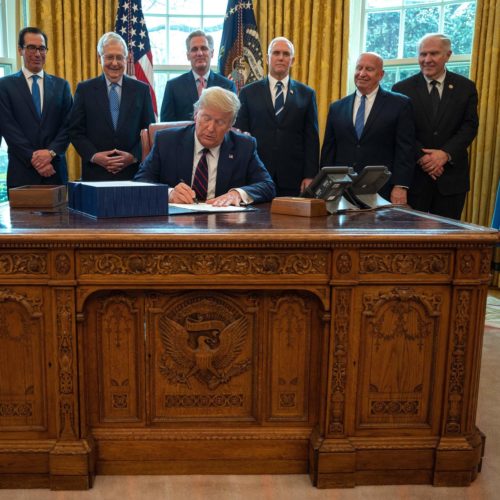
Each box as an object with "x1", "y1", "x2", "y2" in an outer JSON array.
[{"x1": 29, "y1": 0, "x2": 118, "y2": 179}]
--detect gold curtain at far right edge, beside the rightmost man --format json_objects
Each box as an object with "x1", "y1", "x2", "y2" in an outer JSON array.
[{"x1": 465, "y1": 0, "x2": 500, "y2": 287}]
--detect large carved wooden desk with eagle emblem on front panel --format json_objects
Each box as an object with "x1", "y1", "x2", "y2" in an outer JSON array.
[{"x1": 0, "y1": 206, "x2": 497, "y2": 489}]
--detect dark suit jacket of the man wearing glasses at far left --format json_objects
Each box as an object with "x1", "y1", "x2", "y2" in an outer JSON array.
[{"x1": 0, "y1": 71, "x2": 73, "y2": 188}]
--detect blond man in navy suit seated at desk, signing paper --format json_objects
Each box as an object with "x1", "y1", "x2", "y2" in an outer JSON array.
[{"x1": 134, "y1": 87, "x2": 276, "y2": 206}]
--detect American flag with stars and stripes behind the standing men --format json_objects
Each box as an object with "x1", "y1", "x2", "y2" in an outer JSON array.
[{"x1": 115, "y1": 0, "x2": 158, "y2": 115}]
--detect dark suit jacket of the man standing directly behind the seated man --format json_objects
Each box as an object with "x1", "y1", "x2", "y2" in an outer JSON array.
[{"x1": 160, "y1": 71, "x2": 236, "y2": 122}]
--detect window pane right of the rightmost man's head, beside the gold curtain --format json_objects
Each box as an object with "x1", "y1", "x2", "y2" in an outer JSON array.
[{"x1": 444, "y1": 2, "x2": 476, "y2": 54}]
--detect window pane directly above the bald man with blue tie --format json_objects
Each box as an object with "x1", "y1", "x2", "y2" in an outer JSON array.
[{"x1": 365, "y1": 12, "x2": 401, "y2": 59}]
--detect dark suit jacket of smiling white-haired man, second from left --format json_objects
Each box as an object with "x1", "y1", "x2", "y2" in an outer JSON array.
[{"x1": 69, "y1": 75, "x2": 155, "y2": 181}]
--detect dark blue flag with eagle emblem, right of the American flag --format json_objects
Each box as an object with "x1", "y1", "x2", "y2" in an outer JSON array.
[{"x1": 219, "y1": 0, "x2": 264, "y2": 90}]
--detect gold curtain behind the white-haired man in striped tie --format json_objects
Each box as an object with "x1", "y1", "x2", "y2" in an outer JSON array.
[{"x1": 254, "y1": 0, "x2": 349, "y2": 140}]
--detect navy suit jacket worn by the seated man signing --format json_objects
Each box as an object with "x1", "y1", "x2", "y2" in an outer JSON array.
[{"x1": 135, "y1": 125, "x2": 276, "y2": 203}]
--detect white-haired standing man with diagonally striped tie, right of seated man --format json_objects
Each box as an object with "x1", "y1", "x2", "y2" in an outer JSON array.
[{"x1": 236, "y1": 37, "x2": 319, "y2": 196}]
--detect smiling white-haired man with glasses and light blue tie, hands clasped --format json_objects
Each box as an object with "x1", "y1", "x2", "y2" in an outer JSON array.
[{"x1": 69, "y1": 32, "x2": 155, "y2": 181}]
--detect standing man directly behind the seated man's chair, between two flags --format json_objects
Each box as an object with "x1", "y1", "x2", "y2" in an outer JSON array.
[{"x1": 160, "y1": 30, "x2": 236, "y2": 122}]
